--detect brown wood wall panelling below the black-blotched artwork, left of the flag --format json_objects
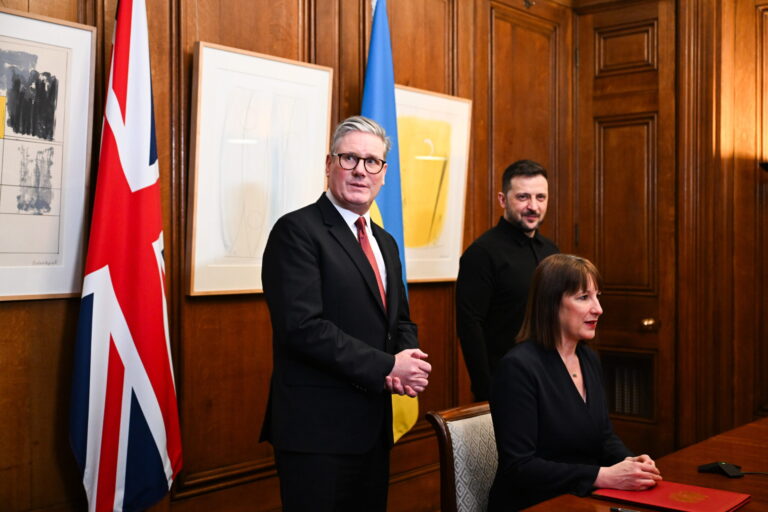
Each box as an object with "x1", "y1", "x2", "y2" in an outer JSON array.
[{"x1": 0, "y1": 299, "x2": 84, "y2": 510}]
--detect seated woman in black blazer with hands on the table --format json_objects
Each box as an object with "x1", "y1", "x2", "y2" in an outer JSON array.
[{"x1": 489, "y1": 254, "x2": 661, "y2": 511}]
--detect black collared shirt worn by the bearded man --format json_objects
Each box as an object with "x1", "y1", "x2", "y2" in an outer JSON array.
[{"x1": 456, "y1": 217, "x2": 560, "y2": 401}]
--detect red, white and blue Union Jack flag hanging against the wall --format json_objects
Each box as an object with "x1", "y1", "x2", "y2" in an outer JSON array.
[{"x1": 70, "y1": 0, "x2": 181, "y2": 511}]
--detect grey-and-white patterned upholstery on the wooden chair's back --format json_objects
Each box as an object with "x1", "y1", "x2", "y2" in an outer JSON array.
[{"x1": 448, "y1": 414, "x2": 498, "y2": 512}]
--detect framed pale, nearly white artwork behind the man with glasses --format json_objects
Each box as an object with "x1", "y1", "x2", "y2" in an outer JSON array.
[{"x1": 187, "y1": 42, "x2": 333, "y2": 295}]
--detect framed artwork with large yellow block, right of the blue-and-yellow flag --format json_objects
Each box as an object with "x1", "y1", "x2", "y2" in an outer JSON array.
[{"x1": 395, "y1": 85, "x2": 472, "y2": 282}]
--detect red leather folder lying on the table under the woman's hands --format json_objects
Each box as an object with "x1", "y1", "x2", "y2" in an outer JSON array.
[{"x1": 592, "y1": 480, "x2": 750, "y2": 512}]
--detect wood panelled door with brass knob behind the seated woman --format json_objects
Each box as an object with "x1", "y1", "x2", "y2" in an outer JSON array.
[{"x1": 574, "y1": 0, "x2": 676, "y2": 456}]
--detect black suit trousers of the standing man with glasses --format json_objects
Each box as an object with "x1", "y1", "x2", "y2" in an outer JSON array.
[{"x1": 275, "y1": 439, "x2": 390, "y2": 512}]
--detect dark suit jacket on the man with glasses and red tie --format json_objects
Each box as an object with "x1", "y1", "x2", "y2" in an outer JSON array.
[{"x1": 261, "y1": 194, "x2": 418, "y2": 453}]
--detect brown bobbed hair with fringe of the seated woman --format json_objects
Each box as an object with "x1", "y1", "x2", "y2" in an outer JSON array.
[{"x1": 516, "y1": 254, "x2": 603, "y2": 348}]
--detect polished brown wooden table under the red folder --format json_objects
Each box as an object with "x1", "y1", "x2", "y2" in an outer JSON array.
[{"x1": 525, "y1": 418, "x2": 768, "y2": 512}]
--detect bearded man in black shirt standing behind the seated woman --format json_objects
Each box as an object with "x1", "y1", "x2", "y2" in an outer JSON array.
[{"x1": 456, "y1": 160, "x2": 560, "y2": 401}]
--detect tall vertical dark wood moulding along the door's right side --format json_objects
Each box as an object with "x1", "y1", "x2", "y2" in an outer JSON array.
[{"x1": 677, "y1": 0, "x2": 715, "y2": 446}]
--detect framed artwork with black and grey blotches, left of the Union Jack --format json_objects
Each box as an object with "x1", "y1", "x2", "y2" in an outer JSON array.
[{"x1": 0, "y1": 9, "x2": 96, "y2": 300}]
